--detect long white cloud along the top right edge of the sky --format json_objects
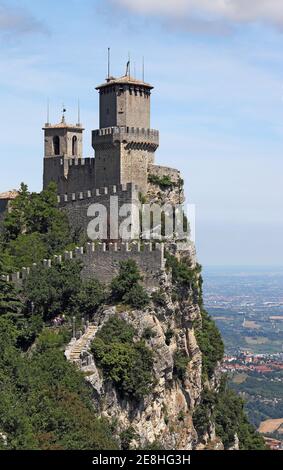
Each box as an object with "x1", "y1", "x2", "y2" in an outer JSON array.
[{"x1": 112, "y1": 0, "x2": 283, "y2": 27}]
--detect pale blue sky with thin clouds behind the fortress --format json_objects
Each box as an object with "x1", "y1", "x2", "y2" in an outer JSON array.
[{"x1": 0, "y1": 0, "x2": 283, "y2": 265}]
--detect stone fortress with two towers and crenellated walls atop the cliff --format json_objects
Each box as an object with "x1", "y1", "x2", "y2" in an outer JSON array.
[{"x1": 1, "y1": 67, "x2": 192, "y2": 287}]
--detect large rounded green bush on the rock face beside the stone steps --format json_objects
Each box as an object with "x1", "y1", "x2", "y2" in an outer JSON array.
[{"x1": 91, "y1": 315, "x2": 153, "y2": 400}]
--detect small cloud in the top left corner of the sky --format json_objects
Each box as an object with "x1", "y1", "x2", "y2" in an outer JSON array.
[{"x1": 0, "y1": 1, "x2": 46, "y2": 34}]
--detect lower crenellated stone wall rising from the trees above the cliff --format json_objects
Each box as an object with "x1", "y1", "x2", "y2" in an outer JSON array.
[{"x1": 1, "y1": 242, "x2": 165, "y2": 287}]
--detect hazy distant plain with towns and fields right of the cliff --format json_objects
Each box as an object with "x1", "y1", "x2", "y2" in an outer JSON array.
[{"x1": 204, "y1": 268, "x2": 283, "y2": 450}]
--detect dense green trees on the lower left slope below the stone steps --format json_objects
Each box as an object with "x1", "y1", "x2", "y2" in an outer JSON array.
[{"x1": 0, "y1": 318, "x2": 118, "y2": 450}]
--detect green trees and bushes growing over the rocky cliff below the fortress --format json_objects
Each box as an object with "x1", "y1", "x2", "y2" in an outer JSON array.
[{"x1": 0, "y1": 185, "x2": 263, "y2": 449}]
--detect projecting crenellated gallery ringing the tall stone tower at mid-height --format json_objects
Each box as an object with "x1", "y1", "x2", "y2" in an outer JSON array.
[{"x1": 92, "y1": 126, "x2": 159, "y2": 152}]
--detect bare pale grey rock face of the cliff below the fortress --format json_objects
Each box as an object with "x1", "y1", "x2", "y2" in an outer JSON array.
[{"x1": 83, "y1": 252, "x2": 223, "y2": 450}]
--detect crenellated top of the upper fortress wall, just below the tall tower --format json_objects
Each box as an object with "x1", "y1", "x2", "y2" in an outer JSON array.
[{"x1": 58, "y1": 183, "x2": 138, "y2": 204}]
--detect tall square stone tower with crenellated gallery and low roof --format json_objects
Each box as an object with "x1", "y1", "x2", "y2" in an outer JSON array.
[{"x1": 92, "y1": 75, "x2": 159, "y2": 191}]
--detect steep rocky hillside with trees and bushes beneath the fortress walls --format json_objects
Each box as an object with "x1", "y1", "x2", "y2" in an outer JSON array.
[{"x1": 0, "y1": 185, "x2": 264, "y2": 449}]
